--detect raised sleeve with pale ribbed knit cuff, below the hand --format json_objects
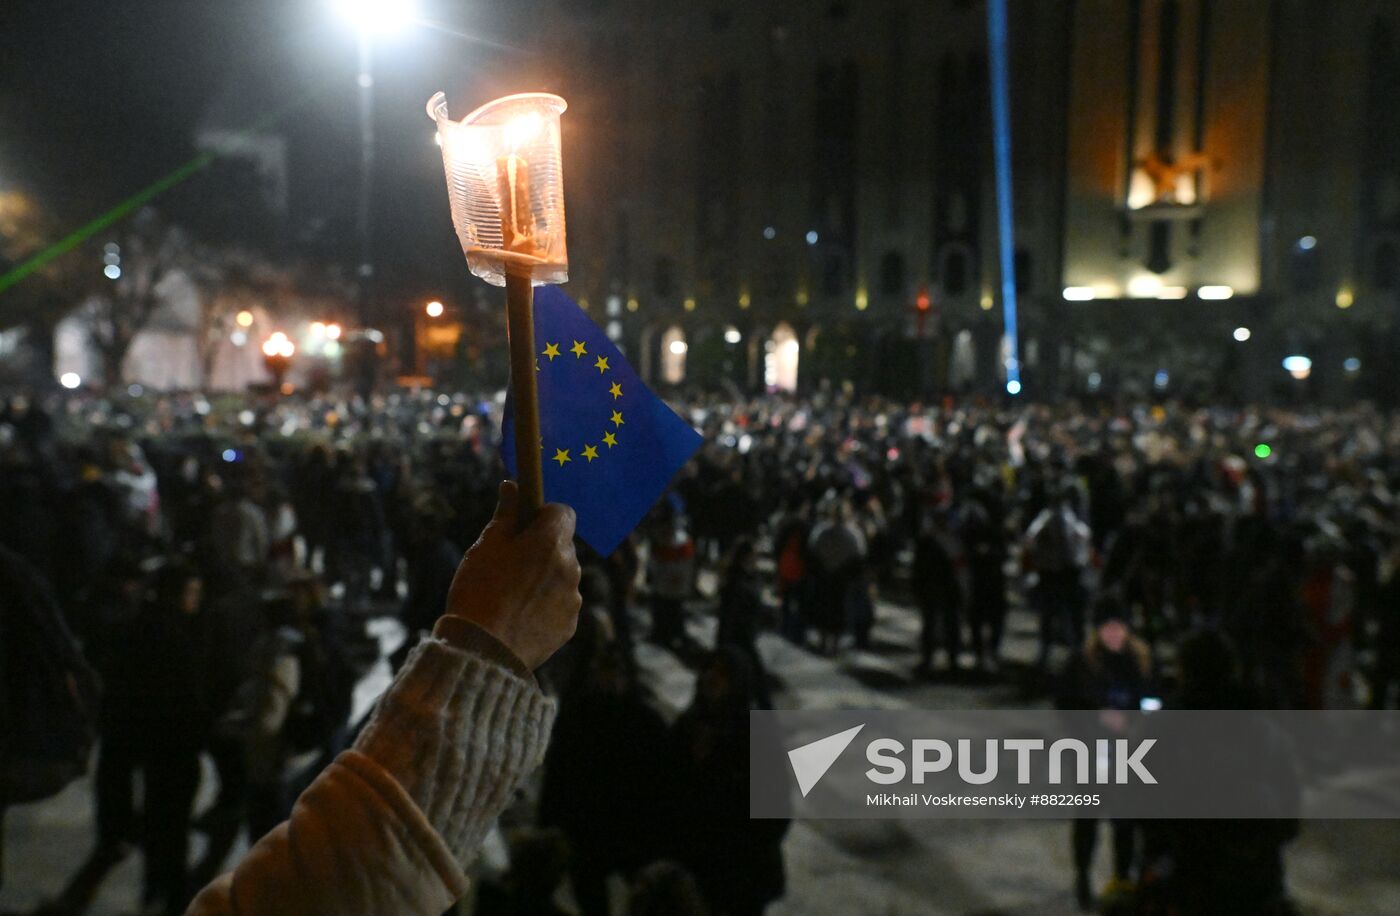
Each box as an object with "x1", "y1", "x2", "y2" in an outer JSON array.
[{"x1": 188, "y1": 627, "x2": 556, "y2": 916}]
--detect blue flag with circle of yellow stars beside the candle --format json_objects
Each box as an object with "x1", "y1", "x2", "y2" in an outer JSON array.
[{"x1": 501, "y1": 286, "x2": 701, "y2": 556}]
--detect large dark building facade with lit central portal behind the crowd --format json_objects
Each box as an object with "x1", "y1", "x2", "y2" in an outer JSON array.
[{"x1": 543, "y1": 0, "x2": 1400, "y2": 396}]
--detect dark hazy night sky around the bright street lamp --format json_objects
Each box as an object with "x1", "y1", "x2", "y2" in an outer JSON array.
[{"x1": 0, "y1": 0, "x2": 547, "y2": 308}]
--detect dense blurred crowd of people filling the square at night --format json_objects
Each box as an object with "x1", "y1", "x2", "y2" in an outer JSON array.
[{"x1": 0, "y1": 391, "x2": 1400, "y2": 916}]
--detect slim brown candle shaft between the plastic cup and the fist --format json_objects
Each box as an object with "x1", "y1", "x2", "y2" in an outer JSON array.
[{"x1": 505, "y1": 265, "x2": 545, "y2": 531}]
